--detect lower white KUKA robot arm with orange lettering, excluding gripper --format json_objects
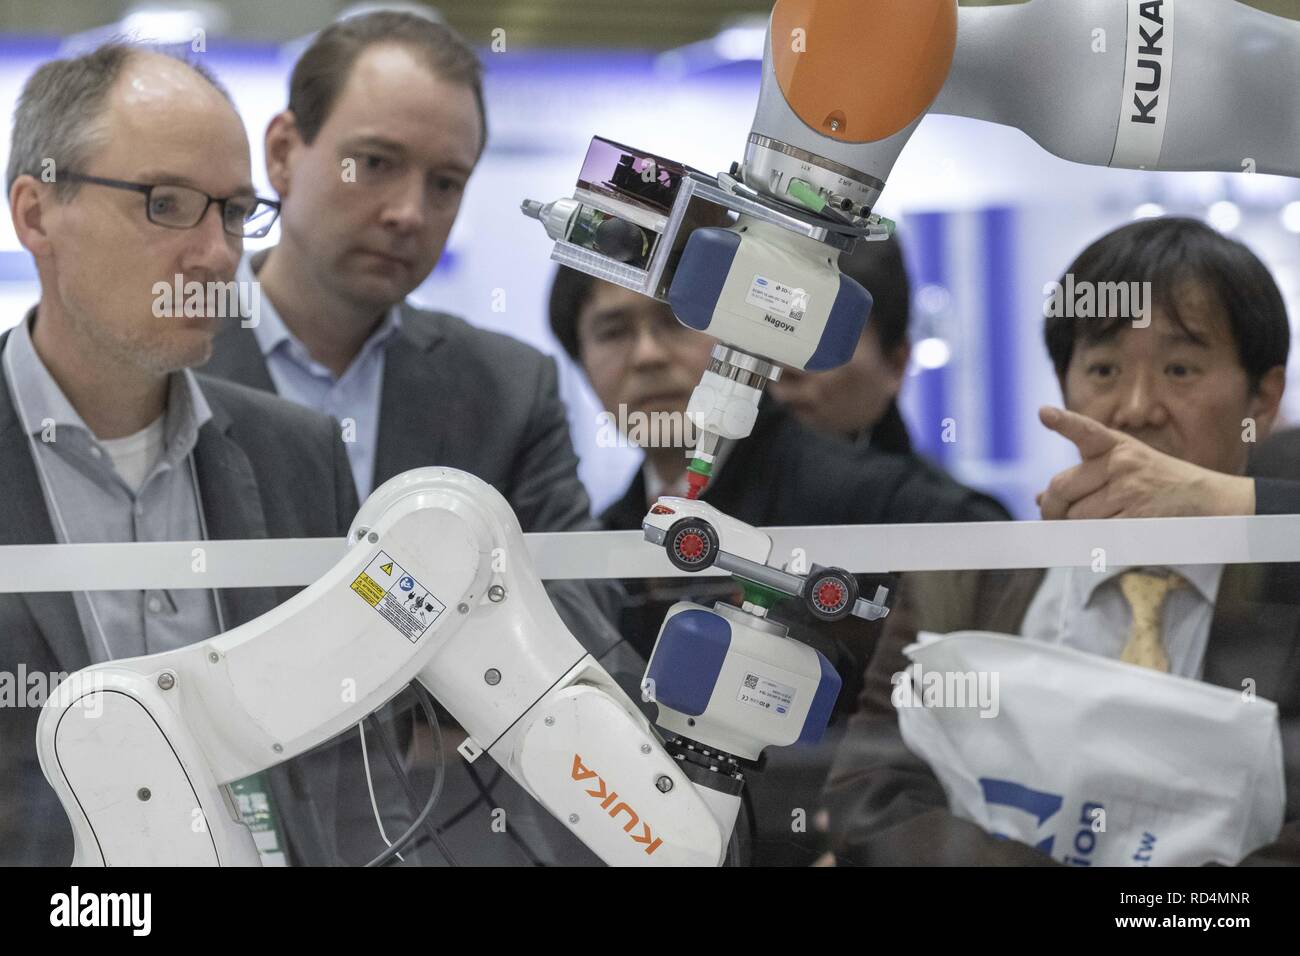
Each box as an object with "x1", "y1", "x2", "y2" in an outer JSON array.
[{"x1": 38, "y1": 468, "x2": 738, "y2": 866}]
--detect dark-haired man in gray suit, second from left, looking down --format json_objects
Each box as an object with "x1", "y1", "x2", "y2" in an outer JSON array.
[{"x1": 204, "y1": 12, "x2": 645, "y2": 864}]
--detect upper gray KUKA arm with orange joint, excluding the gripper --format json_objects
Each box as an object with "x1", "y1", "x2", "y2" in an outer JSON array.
[{"x1": 745, "y1": 0, "x2": 1300, "y2": 215}]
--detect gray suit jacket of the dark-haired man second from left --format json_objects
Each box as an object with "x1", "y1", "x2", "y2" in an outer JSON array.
[{"x1": 203, "y1": 304, "x2": 640, "y2": 658}]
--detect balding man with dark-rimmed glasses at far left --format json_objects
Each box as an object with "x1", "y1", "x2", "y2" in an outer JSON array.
[{"x1": 0, "y1": 44, "x2": 365, "y2": 865}]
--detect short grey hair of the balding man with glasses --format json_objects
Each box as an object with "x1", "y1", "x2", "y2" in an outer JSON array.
[{"x1": 5, "y1": 40, "x2": 234, "y2": 200}]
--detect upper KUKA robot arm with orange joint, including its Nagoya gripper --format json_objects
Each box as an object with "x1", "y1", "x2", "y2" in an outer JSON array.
[{"x1": 524, "y1": 0, "x2": 1300, "y2": 481}]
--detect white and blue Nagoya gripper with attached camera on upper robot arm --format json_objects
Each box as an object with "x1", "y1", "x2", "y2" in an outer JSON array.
[{"x1": 523, "y1": 137, "x2": 892, "y2": 464}]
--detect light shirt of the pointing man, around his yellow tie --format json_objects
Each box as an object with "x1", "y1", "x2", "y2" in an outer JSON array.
[{"x1": 1022, "y1": 564, "x2": 1223, "y2": 680}]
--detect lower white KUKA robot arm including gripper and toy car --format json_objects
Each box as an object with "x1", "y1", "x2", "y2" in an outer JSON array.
[{"x1": 36, "y1": 468, "x2": 887, "y2": 866}]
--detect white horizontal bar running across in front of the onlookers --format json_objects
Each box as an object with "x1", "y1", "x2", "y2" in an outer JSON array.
[{"x1": 0, "y1": 515, "x2": 1300, "y2": 592}]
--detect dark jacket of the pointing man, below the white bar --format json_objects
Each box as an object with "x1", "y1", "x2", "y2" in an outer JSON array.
[{"x1": 823, "y1": 564, "x2": 1300, "y2": 865}]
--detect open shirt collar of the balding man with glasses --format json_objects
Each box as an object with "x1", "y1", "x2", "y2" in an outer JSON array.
[{"x1": 5, "y1": 308, "x2": 212, "y2": 460}]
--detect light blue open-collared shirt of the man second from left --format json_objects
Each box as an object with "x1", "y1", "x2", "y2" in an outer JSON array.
[{"x1": 235, "y1": 255, "x2": 402, "y2": 501}]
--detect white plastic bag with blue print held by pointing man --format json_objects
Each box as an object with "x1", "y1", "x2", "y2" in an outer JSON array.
[{"x1": 893, "y1": 631, "x2": 1286, "y2": 866}]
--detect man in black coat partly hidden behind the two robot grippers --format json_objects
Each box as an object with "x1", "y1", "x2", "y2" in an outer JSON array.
[{"x1": 550, "y1": 268, "x2": 1008, "y2": 864}]
